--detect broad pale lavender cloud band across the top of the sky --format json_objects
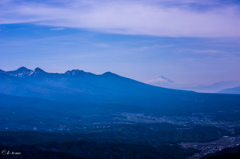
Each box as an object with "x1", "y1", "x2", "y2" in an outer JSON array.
[{"x1": 0, "y1": 0, "x2": 240, "y2": 37}]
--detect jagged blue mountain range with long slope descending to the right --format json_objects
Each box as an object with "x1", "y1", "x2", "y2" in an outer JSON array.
[{"x1": 0, "y1": 67, "x2": 240, "y2": 111}]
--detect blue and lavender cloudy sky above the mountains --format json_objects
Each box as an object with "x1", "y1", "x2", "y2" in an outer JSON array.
[{"x1": 0, "y1": 0, "x2": 240, "y2": 86}]
